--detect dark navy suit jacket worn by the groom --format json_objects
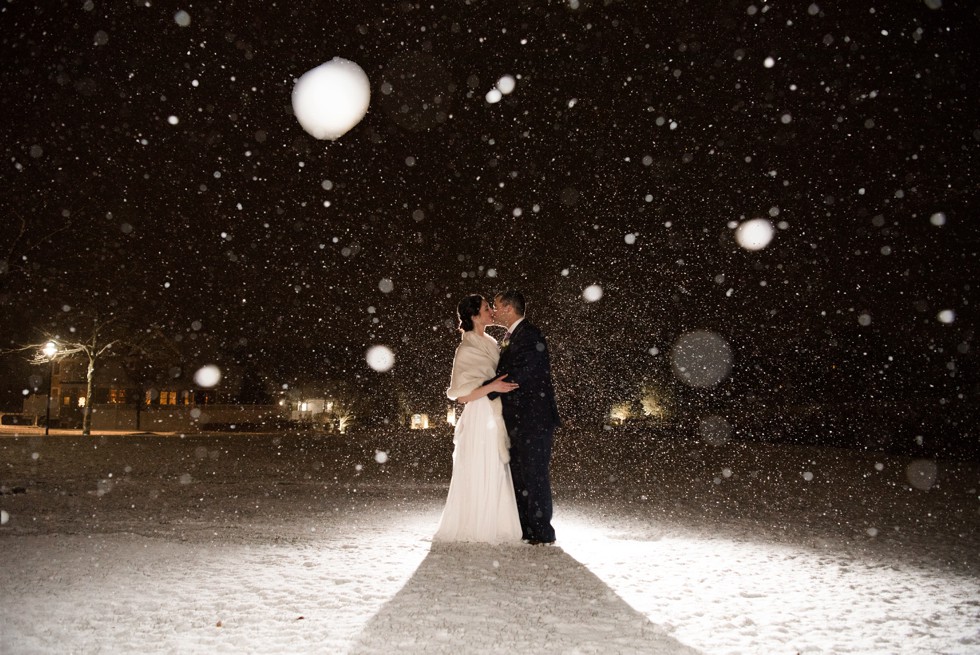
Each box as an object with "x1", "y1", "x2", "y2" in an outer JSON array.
[{"x1": 497, "y1": 319, "x2": 561, "y2": 433}]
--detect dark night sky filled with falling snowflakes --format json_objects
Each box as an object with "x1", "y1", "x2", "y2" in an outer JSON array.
[{"x1": 0, "y1": 0, "x2": 980, "y2": 422}]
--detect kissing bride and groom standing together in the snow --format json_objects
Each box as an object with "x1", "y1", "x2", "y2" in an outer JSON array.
[{"x1": 432, "y1": 290, "x2": 560, "y2": 545}]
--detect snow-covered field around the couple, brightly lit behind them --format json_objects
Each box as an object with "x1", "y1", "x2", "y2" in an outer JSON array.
[{"x1": 0, "y1": 429, "x2": 980, "y2": 655}]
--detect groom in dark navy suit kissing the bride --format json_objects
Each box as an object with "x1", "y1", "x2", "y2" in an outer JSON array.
[{"x1": 491, "y1": 290, "x2": 560, "y2": 545}]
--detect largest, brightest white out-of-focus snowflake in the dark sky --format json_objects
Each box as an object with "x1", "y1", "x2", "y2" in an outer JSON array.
[{"x1": 293, "y1": 57, "x2": 371, "y2": 141}]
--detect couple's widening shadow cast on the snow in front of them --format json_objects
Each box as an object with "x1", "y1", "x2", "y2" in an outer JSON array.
[{"x1": 351, "y1": 544, "x2": 697, "y2": 655}]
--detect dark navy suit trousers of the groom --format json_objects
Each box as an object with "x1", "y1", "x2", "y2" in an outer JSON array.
[{"x1": 510, "y1": 428, "x2": 555, "y2": 541}]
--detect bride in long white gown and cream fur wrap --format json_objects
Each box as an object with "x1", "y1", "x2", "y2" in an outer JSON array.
[{"x1": 432, "y1": 295, "x2": 521, "y2": 544}]
